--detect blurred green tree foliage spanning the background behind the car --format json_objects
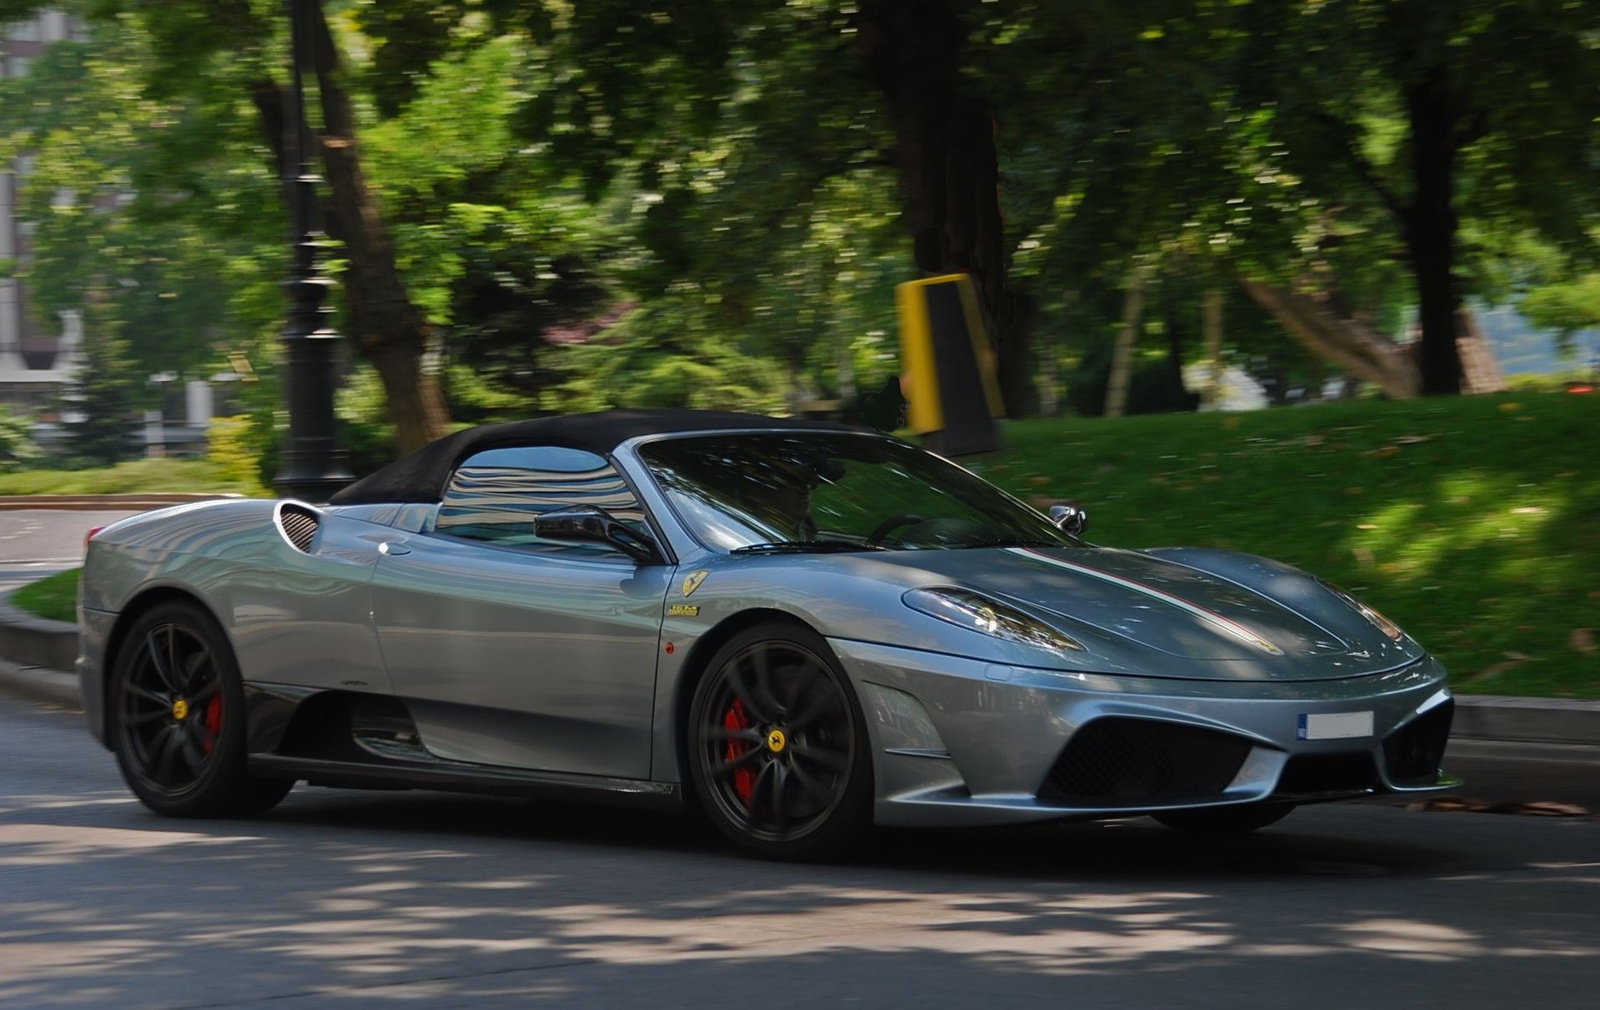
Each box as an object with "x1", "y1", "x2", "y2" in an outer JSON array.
[{"x1": 0, "y1": 0, "x2": 1600, "y2": 438}]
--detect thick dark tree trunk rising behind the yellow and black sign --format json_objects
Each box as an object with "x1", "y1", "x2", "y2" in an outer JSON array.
[{"x1": 859, "y1": 0, "x2": 1032, "y2": 418}]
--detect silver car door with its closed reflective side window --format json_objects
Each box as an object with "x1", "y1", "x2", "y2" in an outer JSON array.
[{"x1": 373, "y1": 447, "x2": 672, "y2": 778}]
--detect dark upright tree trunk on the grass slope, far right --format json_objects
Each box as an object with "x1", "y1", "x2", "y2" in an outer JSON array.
[{"x1": 1405, "y1": 69, "x2": 1461, "y2": 395}]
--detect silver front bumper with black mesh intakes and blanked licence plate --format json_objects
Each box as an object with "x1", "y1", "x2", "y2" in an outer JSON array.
[{"x1": 830, "y1": 639, "x2": 1459, "y2": 826}]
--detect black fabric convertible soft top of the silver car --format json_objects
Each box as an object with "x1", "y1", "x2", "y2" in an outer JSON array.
[{"x1": 318, "y1": 410, "x2": 853, "y2": 504}]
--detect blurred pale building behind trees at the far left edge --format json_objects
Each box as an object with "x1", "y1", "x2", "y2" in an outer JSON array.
[{"x1": 0, "y1": 11, "x2": 83, "y2": 410}]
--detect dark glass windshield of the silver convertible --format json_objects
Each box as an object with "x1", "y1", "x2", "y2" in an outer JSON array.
[{"x1": 638, "y1": 432, "x2": 1078, "y2": 552}]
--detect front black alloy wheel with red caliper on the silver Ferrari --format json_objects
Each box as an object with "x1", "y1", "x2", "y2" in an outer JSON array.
[{"x1": 690, "y1": 624, "x2": 872, "y2": 860}]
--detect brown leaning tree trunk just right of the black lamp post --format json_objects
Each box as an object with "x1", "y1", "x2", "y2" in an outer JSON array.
[{"x1": 310, "y1": 3, "x2": 450, "y2": 453}]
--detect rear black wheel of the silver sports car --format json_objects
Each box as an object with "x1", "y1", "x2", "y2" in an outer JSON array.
[{"x1": 107, "y1": 602, "x2": 294, "y2": 816}]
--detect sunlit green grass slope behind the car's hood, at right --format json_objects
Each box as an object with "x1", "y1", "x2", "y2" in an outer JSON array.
[{"x1": 963, "y1": 394, "x2": 1600, "y2": 698}]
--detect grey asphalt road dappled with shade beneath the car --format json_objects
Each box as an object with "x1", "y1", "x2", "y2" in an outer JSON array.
[{"x1": 0, "y1": 699, "x2": 1600, "y2": 1010}]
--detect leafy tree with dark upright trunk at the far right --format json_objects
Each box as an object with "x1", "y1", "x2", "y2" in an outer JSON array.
[{"x1": 1237, "y1": 0, "x2": 1600, "y2": 394}]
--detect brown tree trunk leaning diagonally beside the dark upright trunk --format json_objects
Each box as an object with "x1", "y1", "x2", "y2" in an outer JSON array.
[{"x1": 1238, "y1": 280, "x2": 1419, "y2": 400}]
